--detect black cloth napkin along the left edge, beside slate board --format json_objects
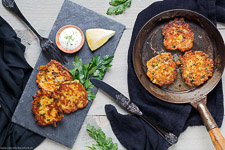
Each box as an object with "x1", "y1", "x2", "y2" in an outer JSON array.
[{"x1": 0, "y1": 16, "x2": 44, "y2": 150}]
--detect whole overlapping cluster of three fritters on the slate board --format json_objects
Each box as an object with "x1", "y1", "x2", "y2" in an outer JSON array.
[{"x1": 32, "y1": 60, "x2": 88, "y2": 127}]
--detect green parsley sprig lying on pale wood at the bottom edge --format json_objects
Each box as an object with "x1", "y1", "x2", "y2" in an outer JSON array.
[{"x1": 86, "y1": 124, "x2": 118, "y2": 150}]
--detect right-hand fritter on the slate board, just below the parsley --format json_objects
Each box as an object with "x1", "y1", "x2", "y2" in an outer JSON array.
[{"x1": 56, "y1": 80, "x2": 88, "y2": 114}]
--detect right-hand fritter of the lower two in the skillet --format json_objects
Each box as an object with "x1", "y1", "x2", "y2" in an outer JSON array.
[{"x1": 181, "y1": 51, "x2": 214, "y2": 86}]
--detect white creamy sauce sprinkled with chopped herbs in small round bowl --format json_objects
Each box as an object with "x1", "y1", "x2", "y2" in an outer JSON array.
[{"x1": 59, "y1": 27, "x2": 82, "y2": 50}]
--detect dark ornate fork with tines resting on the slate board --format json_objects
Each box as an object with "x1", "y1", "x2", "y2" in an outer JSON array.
[{"x1": 2, "y1": 0, "x2": 68, "y2": 64}]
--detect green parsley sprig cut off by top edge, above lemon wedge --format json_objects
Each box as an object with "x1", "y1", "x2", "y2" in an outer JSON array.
[{"x1": 106, "y1": 0, "x2": 132, "y2": 15}]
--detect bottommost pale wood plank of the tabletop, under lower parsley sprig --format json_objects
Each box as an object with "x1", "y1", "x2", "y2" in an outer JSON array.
[{"x1": 36, "y1": 116, "x2": 225, "y2": 150}]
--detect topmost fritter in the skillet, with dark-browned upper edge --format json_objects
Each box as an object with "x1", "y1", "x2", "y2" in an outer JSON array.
[{"x1": 162, "y1": 18, "x2": 194, "y2": 52}]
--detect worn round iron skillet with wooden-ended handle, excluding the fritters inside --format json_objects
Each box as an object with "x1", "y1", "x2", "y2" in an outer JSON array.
[{"x1": 133, "y1": 9, "x2": 225, "y2": 149}]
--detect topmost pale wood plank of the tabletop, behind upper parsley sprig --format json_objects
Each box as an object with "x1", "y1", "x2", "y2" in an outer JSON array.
[{"x1": 0, "y1": 0, "x2": 156, "y2": 30}]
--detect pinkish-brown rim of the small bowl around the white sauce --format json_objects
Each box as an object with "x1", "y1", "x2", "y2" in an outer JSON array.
[{"x1": 55, "y1": 25, "x2": 84, "y2": 53}]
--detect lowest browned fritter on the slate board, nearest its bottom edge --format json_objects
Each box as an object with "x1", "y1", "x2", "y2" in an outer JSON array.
[{"x1": 31, "y1": 89, "x2": 64, "y2": 127}]
